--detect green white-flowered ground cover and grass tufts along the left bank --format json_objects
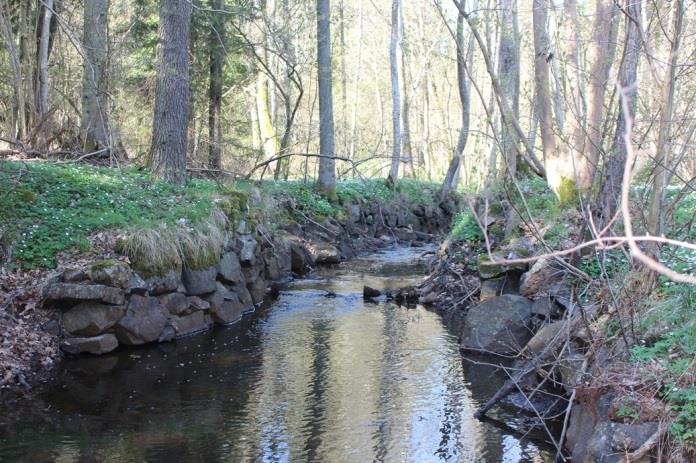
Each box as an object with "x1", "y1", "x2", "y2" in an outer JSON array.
[{"x1": 0, "y1": 161, "x2": 448, "y2": 271}]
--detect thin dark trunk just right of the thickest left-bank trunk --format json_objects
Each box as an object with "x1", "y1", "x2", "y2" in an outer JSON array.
[{"x1": 208, "y1": 0, "x2": 226, "y2": 169}]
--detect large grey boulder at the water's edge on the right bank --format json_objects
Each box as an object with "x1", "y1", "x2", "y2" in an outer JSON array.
[{"x1": 461, "y1": 294, "x2": 533, "y2": 354}]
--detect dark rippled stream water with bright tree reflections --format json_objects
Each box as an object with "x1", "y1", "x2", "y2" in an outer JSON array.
[{"x1": 0, "y1": 248, "x2": 556, "y2": 463}]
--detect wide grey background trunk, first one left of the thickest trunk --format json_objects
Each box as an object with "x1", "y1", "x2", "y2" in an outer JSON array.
[{"x1": 82, "y1": 0, "x2": 112, "y2": 152}]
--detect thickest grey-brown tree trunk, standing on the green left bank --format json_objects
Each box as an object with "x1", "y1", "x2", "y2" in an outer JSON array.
[{"x1": 150, "y1": 0, "x2": 191, "y2": 185}]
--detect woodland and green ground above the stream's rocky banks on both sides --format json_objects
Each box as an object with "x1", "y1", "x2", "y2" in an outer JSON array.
[{"x1": 0, "y1": 0, "x2": 696, "y2": 461}]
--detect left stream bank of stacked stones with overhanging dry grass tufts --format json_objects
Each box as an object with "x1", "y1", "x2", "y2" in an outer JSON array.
[{"x1": 2, "y1": 191, "x2": 457, "y2": 396}]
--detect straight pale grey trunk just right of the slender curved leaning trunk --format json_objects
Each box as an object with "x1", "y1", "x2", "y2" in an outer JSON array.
[{"x1": 498, "y1": 0, "x2": 520, "y2": 177}]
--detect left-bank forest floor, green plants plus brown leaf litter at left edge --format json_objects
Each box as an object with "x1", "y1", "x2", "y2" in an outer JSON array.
[{"x1": 0, "y1": 161, "x2": 446, "y2": 396}]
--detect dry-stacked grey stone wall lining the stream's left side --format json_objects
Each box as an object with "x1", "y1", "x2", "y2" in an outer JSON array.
[{"x1": 43, "y1": 198, "x2": 452, "y2": 355}]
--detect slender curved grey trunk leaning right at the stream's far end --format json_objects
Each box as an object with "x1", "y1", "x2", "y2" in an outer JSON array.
[{"x1": 442, "y1": 2, "x2": 478, "y2": 197}]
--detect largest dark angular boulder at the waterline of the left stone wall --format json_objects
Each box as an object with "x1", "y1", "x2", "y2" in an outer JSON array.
[{"x1": 115, "y1": 295, "x2": 169, "y2": 345}]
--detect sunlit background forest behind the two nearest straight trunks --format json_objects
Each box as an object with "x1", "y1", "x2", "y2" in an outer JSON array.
[{"x1": 0, "y1": 0, "x2": 696, "y2": 203}]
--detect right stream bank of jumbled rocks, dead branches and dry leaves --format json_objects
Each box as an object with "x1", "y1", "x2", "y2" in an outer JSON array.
[{"x1": 418, "y1": 237, "x2": 663, "y2": 463}]
